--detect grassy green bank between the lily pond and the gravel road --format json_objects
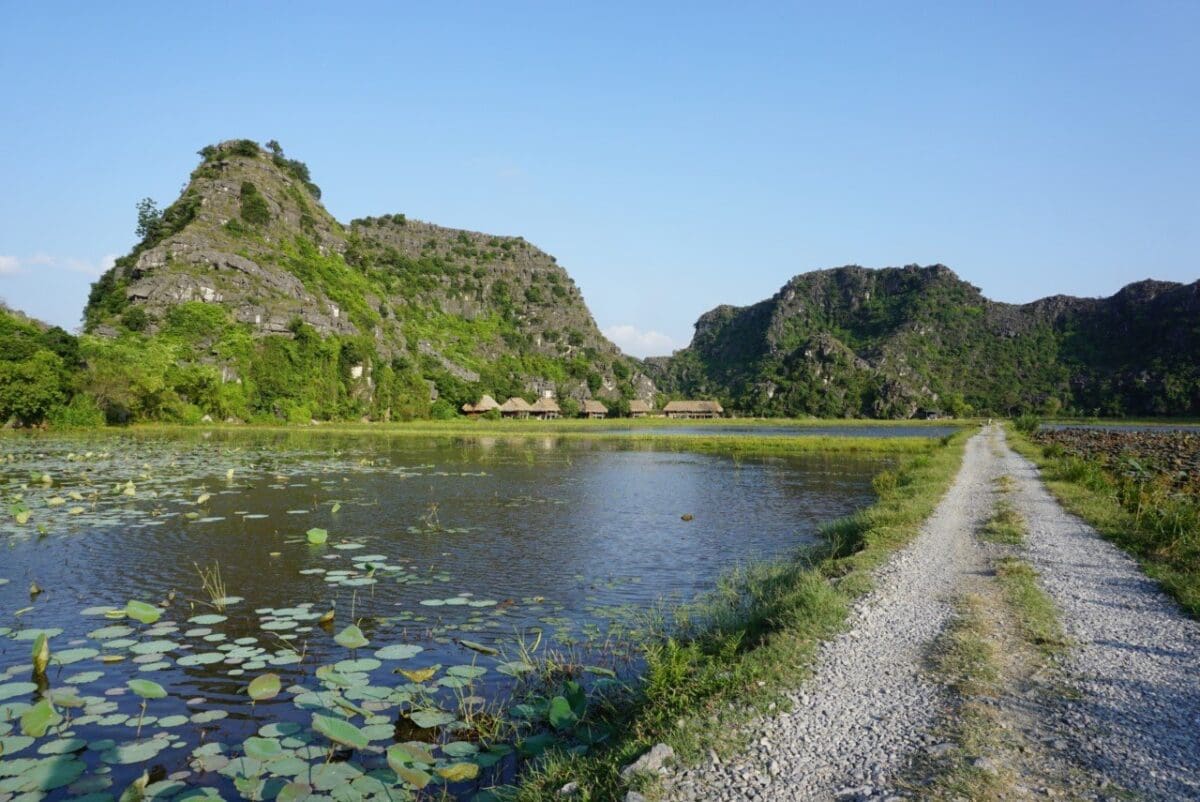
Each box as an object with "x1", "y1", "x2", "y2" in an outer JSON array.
[{"x1": 503, "y1": 431, "x2": 968, "y2": 802}]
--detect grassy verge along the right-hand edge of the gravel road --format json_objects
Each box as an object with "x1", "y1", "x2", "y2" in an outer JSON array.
[{"x1": 1008, "y1": 427, "x2": 1200, "y2": 617}]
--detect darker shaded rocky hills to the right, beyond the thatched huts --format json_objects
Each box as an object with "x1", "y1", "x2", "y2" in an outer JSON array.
[{"x1": 647, "y1": 265, "x2": 1200, "y2": 418}]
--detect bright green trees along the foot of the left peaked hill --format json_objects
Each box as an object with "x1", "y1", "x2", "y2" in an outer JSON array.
[{"x1": 0, "y1": 303, "x2": 431, "y2": 426}]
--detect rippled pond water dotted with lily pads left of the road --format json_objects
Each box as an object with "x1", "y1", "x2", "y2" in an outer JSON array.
[{"x1": 0, "y1": 429, "x2": 883, "y2": 800}]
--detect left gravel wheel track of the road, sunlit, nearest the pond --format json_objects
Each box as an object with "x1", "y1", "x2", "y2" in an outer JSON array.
[{"x1": 665, "y1": 432, "x2": 997, "y2": 800}]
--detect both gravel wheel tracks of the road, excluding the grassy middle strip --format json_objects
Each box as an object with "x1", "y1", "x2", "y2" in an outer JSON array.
[{"x1": 664, "y1": 430, "x2": 1200, "y2": 802}]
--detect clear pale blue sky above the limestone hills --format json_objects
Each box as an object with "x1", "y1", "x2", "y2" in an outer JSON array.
[{"x1": 0, "y1": 0, "x2": 1200, "y2": 355}]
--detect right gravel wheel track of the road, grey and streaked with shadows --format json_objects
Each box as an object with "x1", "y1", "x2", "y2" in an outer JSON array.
[{"x1": 1003, "y1": 434, "x2": 1200, "y2": 800}]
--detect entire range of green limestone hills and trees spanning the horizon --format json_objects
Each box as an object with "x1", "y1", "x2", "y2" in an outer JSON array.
[{"x1": 0, "y1": 139, "x2": 1200, "y2": 425}]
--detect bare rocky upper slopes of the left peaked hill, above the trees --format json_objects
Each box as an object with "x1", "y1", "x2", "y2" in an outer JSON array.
[{"x1": 85, "y1": 140, "x2": 655, "y2": 403}]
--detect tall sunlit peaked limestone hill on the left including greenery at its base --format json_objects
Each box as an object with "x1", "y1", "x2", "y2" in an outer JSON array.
[{"x1": 46, "y1": 139, "x2": 655, "y2": 423}]
